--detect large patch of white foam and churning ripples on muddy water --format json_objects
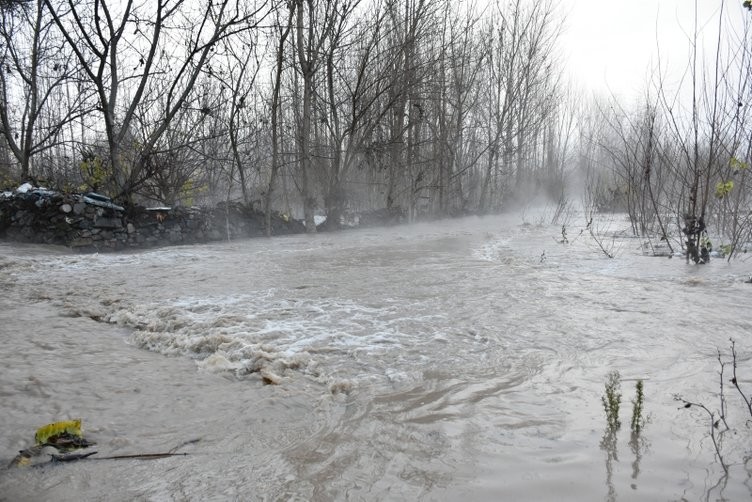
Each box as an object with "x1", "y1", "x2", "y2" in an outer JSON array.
[{"x1": 100, "y1": 290, "x2": 456, "y2": 382}]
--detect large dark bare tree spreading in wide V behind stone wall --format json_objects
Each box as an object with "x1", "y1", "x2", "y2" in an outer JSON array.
[{"x1": 44, "y1": 0, "x2": 265, "y2": 204}]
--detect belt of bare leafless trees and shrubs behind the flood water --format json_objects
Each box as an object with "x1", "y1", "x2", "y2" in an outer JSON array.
[{"x1": 0, "y1": 0, "x2": 752, "y2": 247}]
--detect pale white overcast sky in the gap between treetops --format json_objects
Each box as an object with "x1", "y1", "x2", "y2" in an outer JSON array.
[{"x1": 556, "y1": 0, "x2": 752, "y2": 99}]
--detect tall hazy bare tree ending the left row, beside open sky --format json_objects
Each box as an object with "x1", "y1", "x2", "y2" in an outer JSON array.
[{"x1": 479, "y1": 0, "x2": 561, "y2": 211}]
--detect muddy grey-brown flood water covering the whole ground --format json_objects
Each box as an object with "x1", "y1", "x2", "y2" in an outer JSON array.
[{"x1": 0, "y1": 216, "x2": 752, "y2": 501}]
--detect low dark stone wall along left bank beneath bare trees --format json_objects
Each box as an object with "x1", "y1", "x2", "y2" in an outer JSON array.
[{"x1": 0, "y1": 187, "x2": 305, "y2": 251}]
